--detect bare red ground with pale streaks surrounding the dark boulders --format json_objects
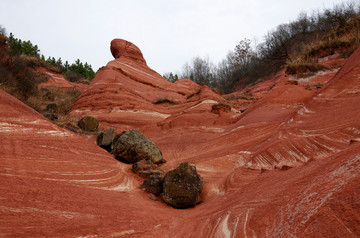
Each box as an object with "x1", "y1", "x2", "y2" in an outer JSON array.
[{"x1": 0, "y1": 40, "x2": 360, "y2": 237}]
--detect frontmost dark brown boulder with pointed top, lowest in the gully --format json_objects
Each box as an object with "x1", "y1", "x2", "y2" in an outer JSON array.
[{"x1": 162, "y1": 162, "x2": 203, "y2": 208}]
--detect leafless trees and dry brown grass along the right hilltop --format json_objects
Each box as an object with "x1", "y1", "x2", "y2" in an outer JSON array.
[{"x1": 164, "y1": 3, "x2": 360, "y2": 93}]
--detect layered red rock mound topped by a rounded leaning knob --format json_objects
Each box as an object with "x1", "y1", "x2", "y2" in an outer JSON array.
[{"x1": 70, "y1": 39, "x2": 229, "y2": 132}]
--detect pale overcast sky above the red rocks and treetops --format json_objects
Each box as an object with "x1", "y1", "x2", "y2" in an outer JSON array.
[{"x1": 0, "y1": 0, "x2": 350, "y2": 74}]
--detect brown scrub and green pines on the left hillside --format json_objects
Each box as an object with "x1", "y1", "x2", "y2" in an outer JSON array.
[{"x1": 0, "y1": 28, "x2": 82, "y2": 116}]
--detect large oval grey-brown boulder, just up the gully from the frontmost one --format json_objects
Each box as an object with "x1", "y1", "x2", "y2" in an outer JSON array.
[{"x1": 111, "y1": 130, "x2": 163, "y2": 164}]
